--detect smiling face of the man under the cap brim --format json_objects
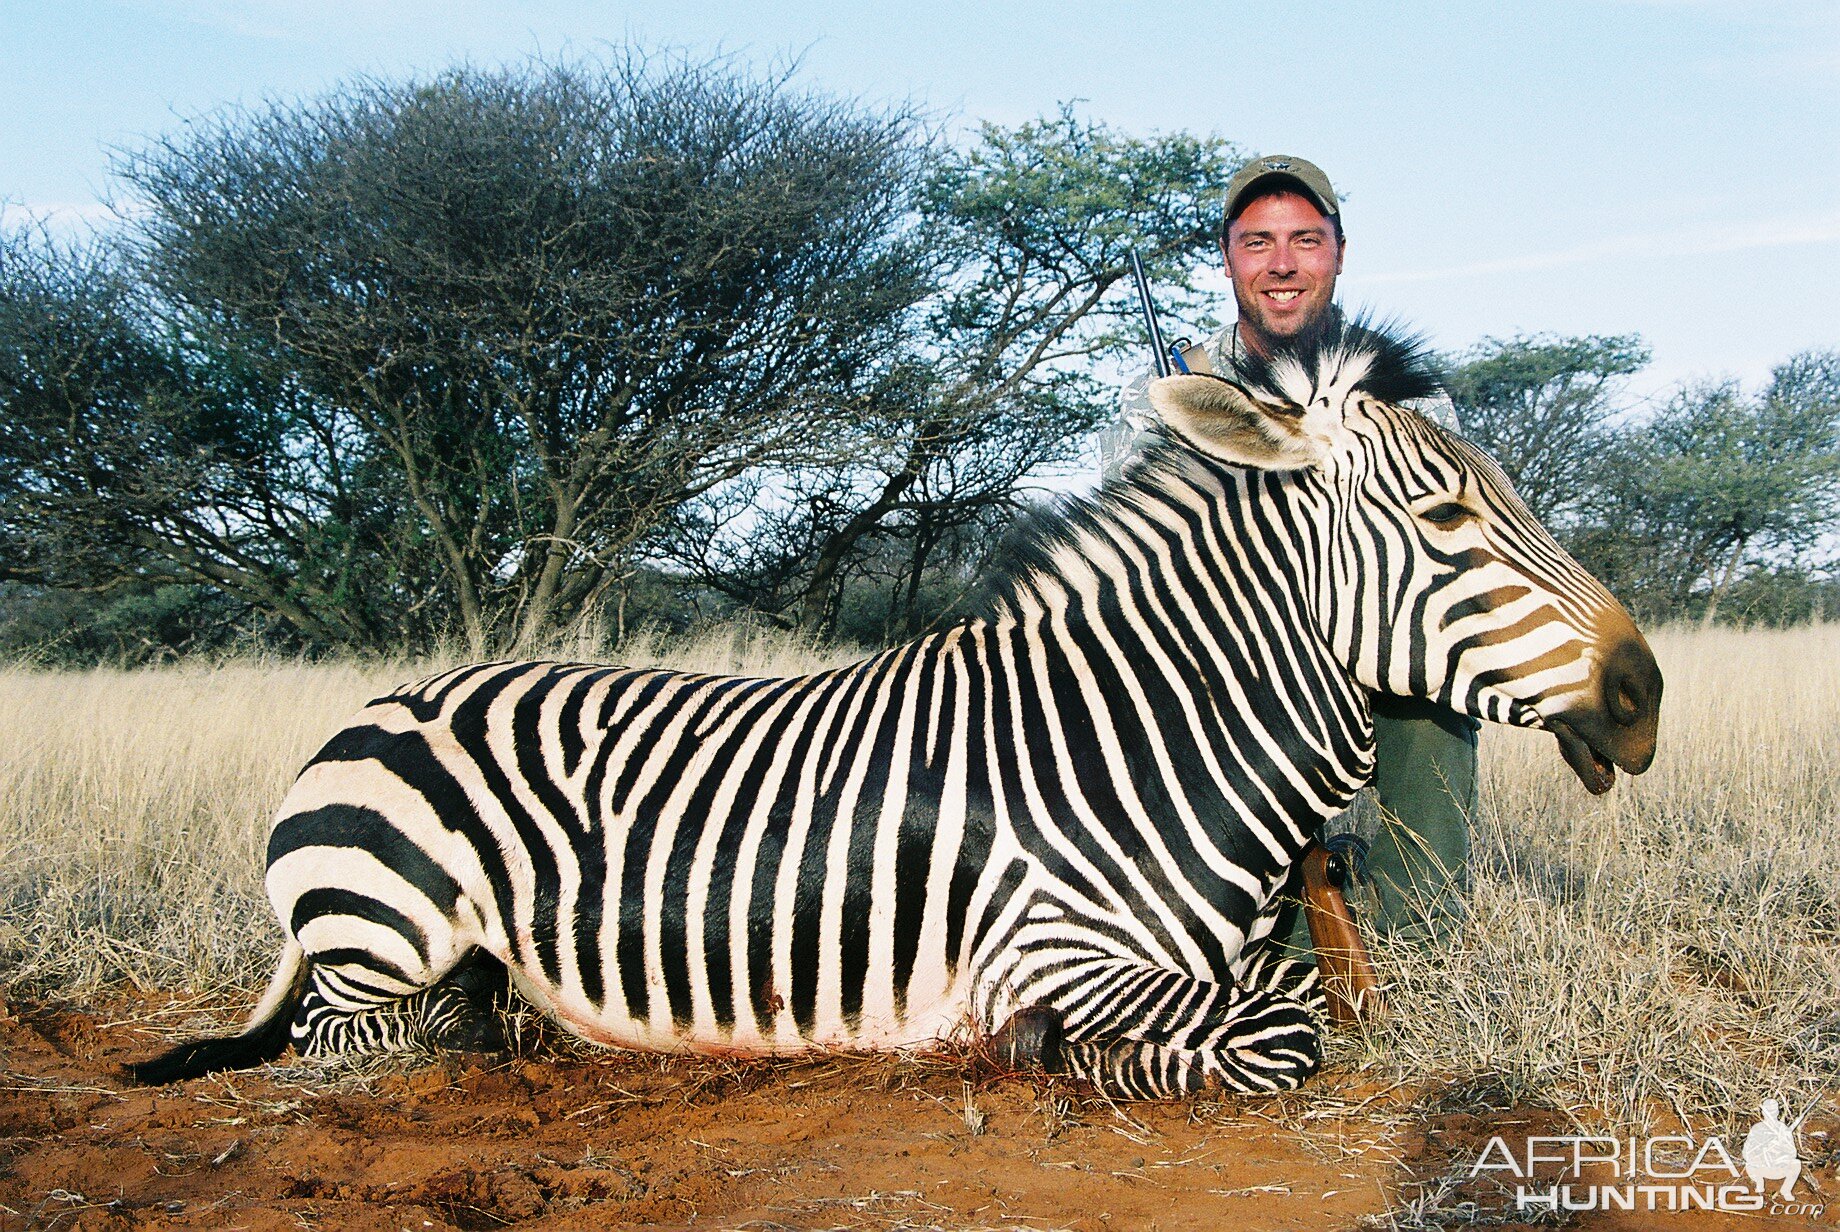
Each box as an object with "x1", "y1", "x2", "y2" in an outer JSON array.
[{"x1": 1222, "y1": 193, "x2": 1341, "y2": 351}]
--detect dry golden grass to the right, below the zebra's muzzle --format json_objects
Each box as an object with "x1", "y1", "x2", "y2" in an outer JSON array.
[{"x1": 1358, "y1": 625, "x2": 1840, "y2": 1129}]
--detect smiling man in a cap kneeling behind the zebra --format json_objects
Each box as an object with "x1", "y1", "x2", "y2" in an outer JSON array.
[{"x1": 1106, "y1": 156, "x2": 1481, "y2": 953}]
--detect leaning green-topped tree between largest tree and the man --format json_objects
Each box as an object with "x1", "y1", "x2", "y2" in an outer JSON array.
[{"x1": 662, "y1": 108, "x2": 1238, "y2": 633}]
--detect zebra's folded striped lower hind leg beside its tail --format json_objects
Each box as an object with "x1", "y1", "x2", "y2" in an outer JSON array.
[{"x1": 293, "y1": 951, "x2": 510, "y2": 1055}]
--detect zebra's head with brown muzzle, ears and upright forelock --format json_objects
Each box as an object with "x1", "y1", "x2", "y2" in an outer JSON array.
[{"x1": 1150, "y1": 322, "x2": 1662, "y2": 793}]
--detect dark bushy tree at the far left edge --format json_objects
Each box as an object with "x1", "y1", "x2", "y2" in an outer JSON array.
[{"x1": 0, "y1": 223, "x2": 386, "y2": 642}]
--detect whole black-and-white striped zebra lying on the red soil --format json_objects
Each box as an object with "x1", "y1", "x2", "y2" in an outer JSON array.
[{"x1": 122, "y1": 320, "x2": 1662, "y2": 1098}]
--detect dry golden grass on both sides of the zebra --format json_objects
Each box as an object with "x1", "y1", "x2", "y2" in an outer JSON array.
[{"x1": 0, "y1": 625, "x2": 1840, "y2": 1125}]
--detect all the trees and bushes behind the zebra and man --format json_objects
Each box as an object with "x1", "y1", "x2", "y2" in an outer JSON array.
[{"x1": 0, "y1": 50, "x2": 1840, "y2": 658}]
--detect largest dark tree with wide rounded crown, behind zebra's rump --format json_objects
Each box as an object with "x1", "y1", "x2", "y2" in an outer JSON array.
[{"x1": 0, "y1": 53, "x2": 929, "y2": 653}]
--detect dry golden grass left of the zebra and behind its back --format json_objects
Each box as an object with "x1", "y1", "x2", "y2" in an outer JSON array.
[{"x1": 0, "y1": 625, "x2": 861, "y2": 997}]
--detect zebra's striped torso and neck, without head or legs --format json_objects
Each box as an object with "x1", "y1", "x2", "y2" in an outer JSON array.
[{"x1": 269, "y1": 444, "x2": 1369, "y2": 1073}]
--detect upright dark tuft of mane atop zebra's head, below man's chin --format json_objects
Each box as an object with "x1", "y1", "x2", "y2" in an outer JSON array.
[{"x1": 1222, "y1": 309, "x2": 1444, "y2": 406}]
